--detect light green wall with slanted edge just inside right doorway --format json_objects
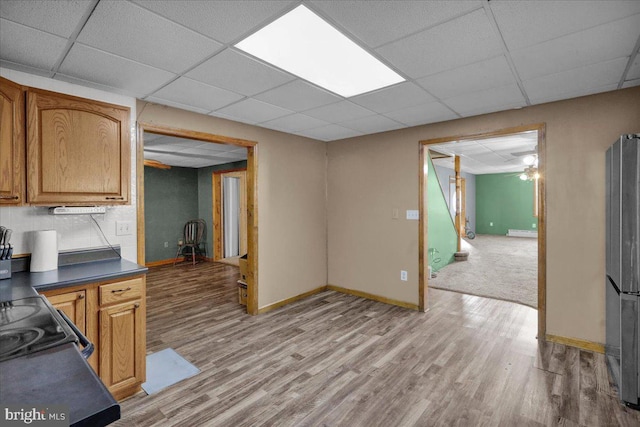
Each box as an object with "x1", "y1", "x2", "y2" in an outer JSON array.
[{"x1": 427, "y1": 156, "x2": 458, "y2": 271}]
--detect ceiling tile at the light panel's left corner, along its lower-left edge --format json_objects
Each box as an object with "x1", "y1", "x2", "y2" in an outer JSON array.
[{"x1": 186, "y1": 49, "x2": 294, "y2": 96}]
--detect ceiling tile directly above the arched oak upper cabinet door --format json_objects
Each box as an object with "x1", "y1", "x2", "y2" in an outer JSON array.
[{"x1": 60, "y1": 43, "x2": 175, "y2": 98}]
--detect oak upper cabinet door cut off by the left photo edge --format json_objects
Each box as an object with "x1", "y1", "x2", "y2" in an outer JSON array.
[{"x1": 0, "y1": 77, "x2": 25, "y2": 205}]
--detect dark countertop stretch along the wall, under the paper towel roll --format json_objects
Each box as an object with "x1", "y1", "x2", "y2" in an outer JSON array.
[{"x1": 0, "y1": 258, "x2": 148, "y2": 302}]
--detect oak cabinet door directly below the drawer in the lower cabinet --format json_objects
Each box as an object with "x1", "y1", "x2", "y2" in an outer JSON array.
[{"x1": 100, "y1": 300, "x2": 146, "y2": 399}]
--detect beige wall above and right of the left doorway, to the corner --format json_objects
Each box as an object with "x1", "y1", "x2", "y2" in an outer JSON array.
[{"x1": 138, "y1": 102, "x2": 327, "y2": 307}]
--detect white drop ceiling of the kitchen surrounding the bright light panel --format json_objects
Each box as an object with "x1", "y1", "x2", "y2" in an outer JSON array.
[{"x1": 0, "y1": 0, "x2": 640, "y2": 145}]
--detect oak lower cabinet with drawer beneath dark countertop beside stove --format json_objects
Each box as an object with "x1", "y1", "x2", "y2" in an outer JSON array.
[{"x1": 43, "y1": 276, "x2": 146, "y2": 400}]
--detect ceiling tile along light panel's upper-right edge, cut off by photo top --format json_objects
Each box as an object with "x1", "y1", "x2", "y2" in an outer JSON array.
[{"x1": 311, "y1": 0, "x2": 482, "y2": 47}]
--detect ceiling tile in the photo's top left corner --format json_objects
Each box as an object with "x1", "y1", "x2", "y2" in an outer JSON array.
[{"x1": 0, "y1": 0, "x2": 92, "y2": 37}]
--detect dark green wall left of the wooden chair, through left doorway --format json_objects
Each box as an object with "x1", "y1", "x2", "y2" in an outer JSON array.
[{"x1": 144, "y1": 166, "x2": 198, "y2": 262}]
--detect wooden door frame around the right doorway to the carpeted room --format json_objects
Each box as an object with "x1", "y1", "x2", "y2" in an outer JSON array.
[{"x1": 418, "y1": 123, "x2": 547, "y2": 340}]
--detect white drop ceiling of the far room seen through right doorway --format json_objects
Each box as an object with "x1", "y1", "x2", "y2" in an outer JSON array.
[{"x1": 429, "y1": 131, "x2": 538, "y2": 175}]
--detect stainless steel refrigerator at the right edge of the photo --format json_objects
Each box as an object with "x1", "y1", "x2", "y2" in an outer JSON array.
[{"x1": 605, "y1": 134, "x2": 640, "y2": 409}]
